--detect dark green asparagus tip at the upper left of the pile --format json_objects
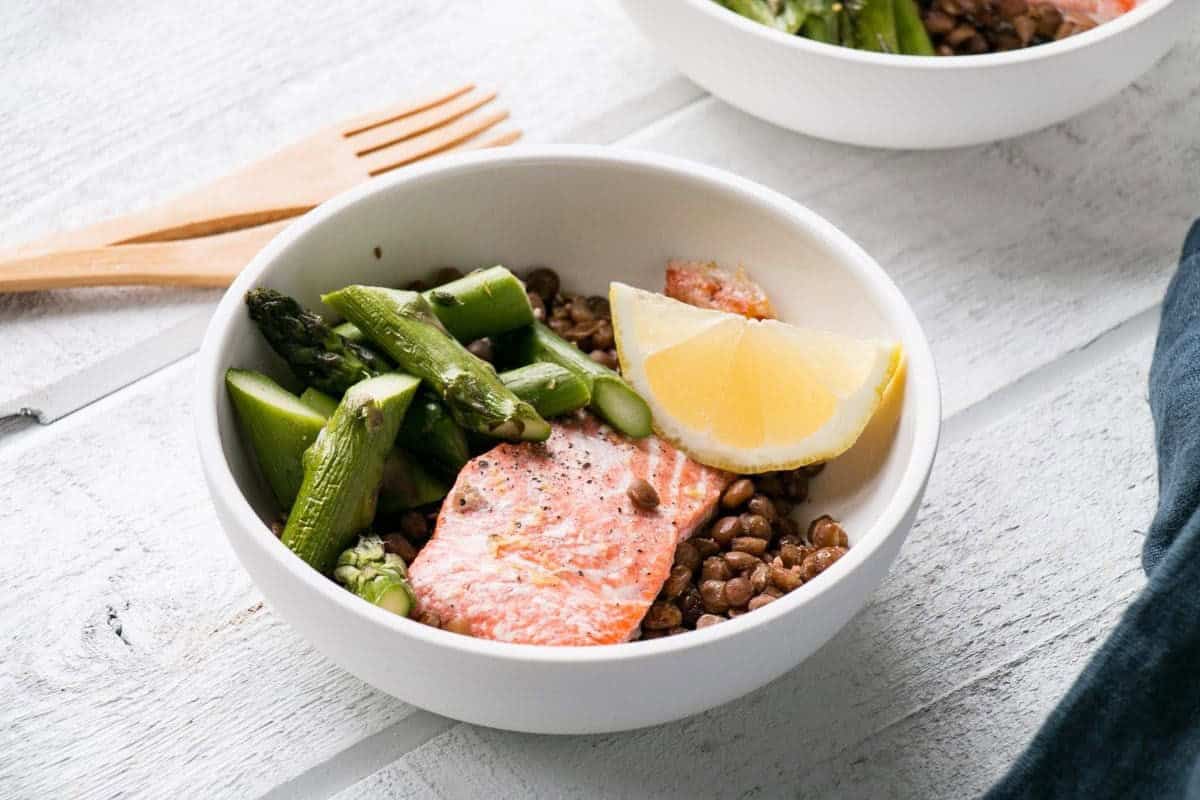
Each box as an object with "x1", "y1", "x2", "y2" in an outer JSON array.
[{"x1": 246, "y1": 288, "x2": 391, "y2": 395}]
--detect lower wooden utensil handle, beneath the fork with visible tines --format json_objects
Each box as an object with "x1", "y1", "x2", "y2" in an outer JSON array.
[{"x1": 0, "y1": 222, "x2": 288, "y2": 293}]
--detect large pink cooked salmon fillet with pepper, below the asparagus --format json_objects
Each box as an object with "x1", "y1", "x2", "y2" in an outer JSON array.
[{"x1": 408, "y1": 414, "x2": 732, "y2": 645}]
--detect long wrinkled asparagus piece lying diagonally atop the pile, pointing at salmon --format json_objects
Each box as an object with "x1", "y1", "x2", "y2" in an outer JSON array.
[{"x1": 322, "y1": 285, "x2": 550, "y2": 441}]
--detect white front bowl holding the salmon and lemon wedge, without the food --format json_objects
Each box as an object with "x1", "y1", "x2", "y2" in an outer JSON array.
[{"x1": 196, "y1": 148, "x2": 940, "y2": 733}]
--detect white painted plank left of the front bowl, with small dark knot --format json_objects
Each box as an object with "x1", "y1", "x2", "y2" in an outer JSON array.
[{"x1": 0, "y1": 359, "x2": 410, "y2": 798}]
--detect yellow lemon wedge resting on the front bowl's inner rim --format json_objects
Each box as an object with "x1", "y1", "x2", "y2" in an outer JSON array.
[{"x1": 608, "y1": 283, "x2": 902, "y2": 473}]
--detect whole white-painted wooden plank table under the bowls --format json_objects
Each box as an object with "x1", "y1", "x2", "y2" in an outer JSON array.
[{"x1": 0, "y1": 0, "x2": 1200, "y2": 798}]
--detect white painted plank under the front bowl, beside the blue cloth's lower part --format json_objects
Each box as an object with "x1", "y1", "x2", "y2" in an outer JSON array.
[{"x1": 341, "y1": 338, "x2": 1156, "y2": 799}]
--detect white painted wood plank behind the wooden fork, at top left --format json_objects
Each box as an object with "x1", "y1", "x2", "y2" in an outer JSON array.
[{"x1": 0, "y1": 0, "x2": 701, "y2": 403}]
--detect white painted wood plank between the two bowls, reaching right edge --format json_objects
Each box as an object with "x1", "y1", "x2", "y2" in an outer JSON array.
[{"x1": 629, "y1": 17, "x2": 1200, "y2": 414}]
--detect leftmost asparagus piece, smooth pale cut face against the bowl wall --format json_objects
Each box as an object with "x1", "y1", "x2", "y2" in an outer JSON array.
[{"x1": 226, "y1": 369, "x2": 325, "y2": 509}]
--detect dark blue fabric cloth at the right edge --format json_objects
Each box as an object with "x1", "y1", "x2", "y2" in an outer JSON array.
[{"x1": 986, "y1": 221, "x2": 1200, "y2": 800}]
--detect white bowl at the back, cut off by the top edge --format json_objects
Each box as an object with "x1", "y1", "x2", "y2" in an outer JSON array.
[{"x1": 622, "y1": 0, "x2": 1196, "y2": 149}]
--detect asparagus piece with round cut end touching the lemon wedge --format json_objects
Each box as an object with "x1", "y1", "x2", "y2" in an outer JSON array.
[{"x1": 500, "y1": 323, "x2": 652, "y2": 439}]
